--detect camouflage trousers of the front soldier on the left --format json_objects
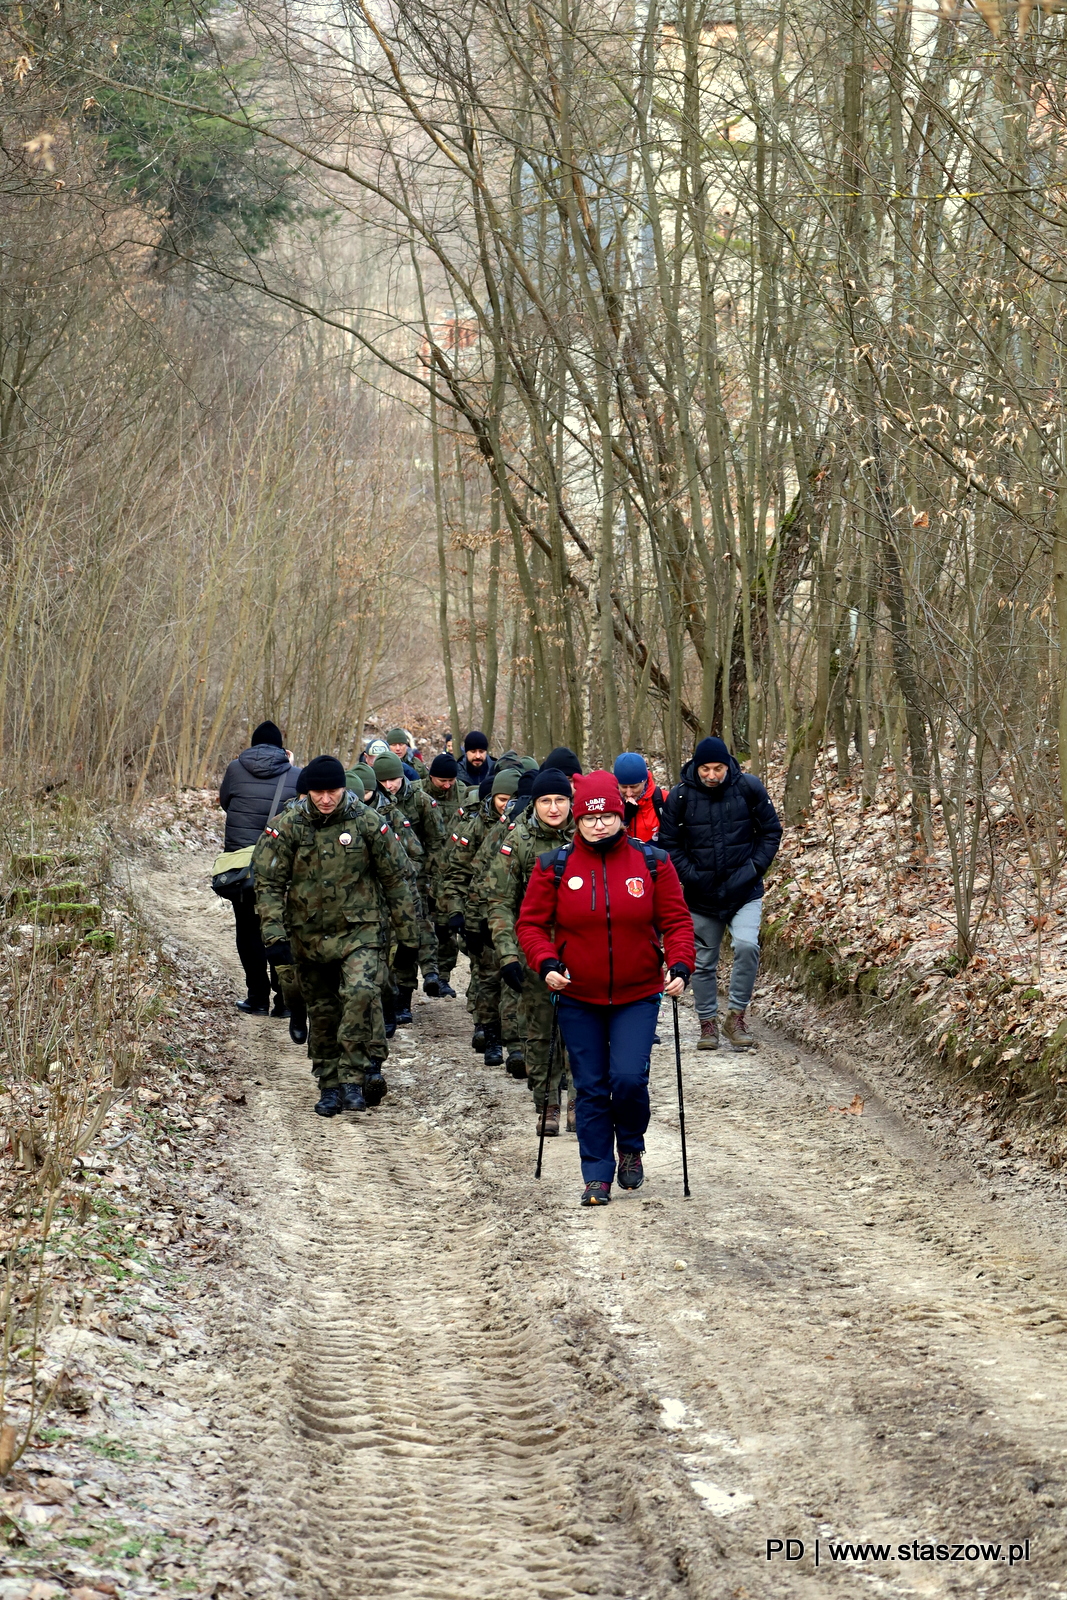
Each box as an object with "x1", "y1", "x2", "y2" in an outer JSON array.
[{"x1": 296, "y1": 946, "x2": 389, "y2": 1088}]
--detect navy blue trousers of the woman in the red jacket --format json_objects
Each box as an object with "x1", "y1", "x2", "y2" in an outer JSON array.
[{"x1": 558, "y1": 995, "x2": 661, "y2": 1184}]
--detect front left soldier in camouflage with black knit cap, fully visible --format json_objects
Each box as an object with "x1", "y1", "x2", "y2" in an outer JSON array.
[{"x1": 256, "y1": 755, "x2": 418, "y2": 1117}]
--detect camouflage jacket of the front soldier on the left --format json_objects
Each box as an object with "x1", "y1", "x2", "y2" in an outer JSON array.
[{"x1": 254, "y1": 794, "x2": 419, "y2": 962}]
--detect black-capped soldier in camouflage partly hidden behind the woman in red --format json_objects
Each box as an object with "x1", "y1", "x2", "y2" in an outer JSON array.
[{"x1": 486, "y1": 768, "x2": 574, "y2": 1134}]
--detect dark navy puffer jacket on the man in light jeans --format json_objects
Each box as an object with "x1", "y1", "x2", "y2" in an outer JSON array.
[{"x1": 659, "y1": 755, "x2": 782, "y2": 922}]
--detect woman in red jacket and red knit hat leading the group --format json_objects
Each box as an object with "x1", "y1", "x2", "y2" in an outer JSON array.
[{"x1": 515, "y1": 771, "x2": 694, "y2": 1205}]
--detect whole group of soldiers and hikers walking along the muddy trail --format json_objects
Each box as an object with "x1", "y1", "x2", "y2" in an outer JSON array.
[{"x1": 219, "y1": 722, "x2": 782, "y2": 1205}]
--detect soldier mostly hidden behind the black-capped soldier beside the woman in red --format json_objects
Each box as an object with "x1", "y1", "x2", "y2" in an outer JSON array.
[{"x1": 443, "y1": 768, "x2": 526, "y2": 1078}]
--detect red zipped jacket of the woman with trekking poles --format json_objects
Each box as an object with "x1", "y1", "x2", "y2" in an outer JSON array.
[{"x1": 515, "y1": 832, "x2": 696, "y2": 1005}]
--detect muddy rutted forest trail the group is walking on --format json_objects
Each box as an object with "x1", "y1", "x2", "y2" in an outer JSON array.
[{"x1": 133, "y1": 856, "x2": 1067, "y2": 1600}]
